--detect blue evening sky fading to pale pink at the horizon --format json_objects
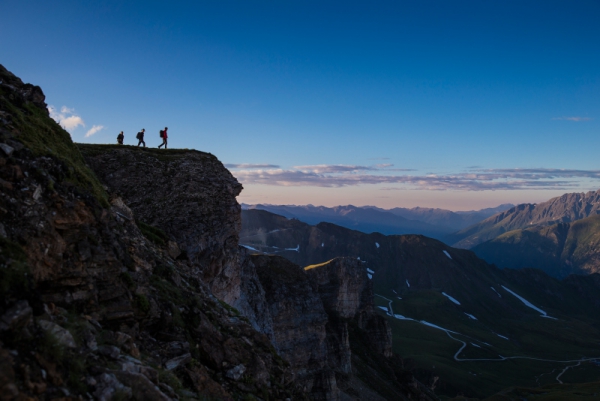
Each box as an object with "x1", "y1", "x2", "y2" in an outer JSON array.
[{"x1": 0, "y1": 0, "x2": 600, "y2": 210}]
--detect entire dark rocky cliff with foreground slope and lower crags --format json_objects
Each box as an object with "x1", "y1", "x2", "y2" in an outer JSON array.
[{"x1": 0, "y1": 66, "x2": 440, "y2": 400}]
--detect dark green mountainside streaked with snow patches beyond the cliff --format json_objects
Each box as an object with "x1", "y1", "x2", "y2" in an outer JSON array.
[{"x1": 240, "y1": 210, "x2": 600, "y2": 398}]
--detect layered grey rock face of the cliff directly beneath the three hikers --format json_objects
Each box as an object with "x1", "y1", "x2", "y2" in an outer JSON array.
[{"x1": 80, "y1": 145, "x2": 242, "y2": 304}]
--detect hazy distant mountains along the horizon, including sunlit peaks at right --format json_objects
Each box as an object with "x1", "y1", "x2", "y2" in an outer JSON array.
[{"x1": 242, "y1": 190, "x2": 600, "y2": 278}]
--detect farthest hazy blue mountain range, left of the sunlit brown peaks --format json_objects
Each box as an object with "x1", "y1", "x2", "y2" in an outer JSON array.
[{"x1": 242, "y1": 204, "x2": 514, "y2": 239}]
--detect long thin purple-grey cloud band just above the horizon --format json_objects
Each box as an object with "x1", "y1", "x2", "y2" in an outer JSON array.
[{"x1": 227, "y1": 164, "x2": 600, "y2": 191}]
